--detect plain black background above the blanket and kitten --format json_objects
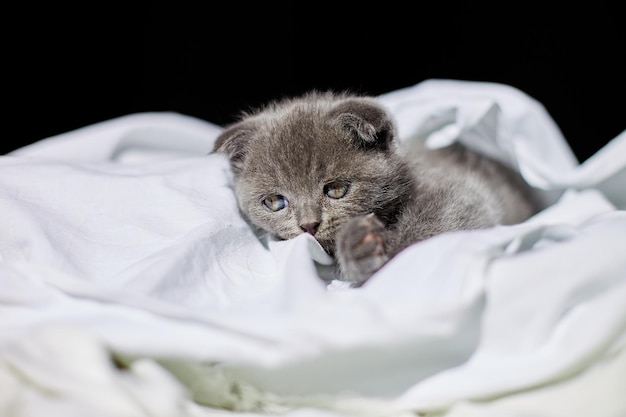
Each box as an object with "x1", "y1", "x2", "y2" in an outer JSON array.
[{"x1": 0, "y1": 2, "x2": 626, "y2": 161}]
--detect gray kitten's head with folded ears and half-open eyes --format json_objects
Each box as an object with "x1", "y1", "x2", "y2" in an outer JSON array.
[{"x1": 214, "y1": 92, "x2": 410, "y2": 254}]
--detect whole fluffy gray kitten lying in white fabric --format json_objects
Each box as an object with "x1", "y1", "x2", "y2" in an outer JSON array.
[{"x1": 214, "y1": 92, "x2": 539, "y2": 286}]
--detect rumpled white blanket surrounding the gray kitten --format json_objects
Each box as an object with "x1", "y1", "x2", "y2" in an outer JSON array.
[{"x1": 0, "y1": 80, "x2": 626, "y2": 417}]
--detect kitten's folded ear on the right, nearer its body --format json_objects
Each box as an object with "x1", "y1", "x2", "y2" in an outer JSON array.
[{"x1": 330, "y1": 98, "x2": 395, "y2": 149}]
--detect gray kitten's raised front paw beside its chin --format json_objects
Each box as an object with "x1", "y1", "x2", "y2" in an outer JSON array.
[{"x1": 337, "y1": 213, "x2": 389, "y2": 286}]
